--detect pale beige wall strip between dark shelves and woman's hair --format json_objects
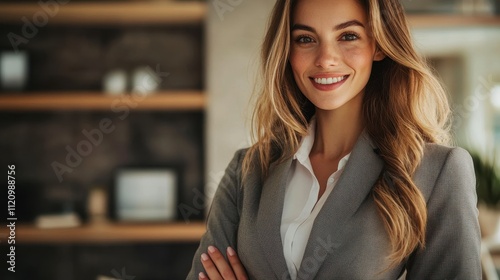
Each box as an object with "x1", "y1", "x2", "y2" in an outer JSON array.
[{"x1": 205, "y1": 0, "x2": 275, "y2": 206}]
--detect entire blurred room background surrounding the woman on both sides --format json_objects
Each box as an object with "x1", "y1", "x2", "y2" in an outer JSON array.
[{"x1": 0, "y1": 0, "x2": 500, "y2": 280}]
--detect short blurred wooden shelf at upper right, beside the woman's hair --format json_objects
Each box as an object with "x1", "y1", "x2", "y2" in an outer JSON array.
[{"x1": 408, "y1": 14, "x2": 500, "y2": 28}]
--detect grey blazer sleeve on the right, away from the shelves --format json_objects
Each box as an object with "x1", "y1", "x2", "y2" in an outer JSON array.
[{"x1": 407, "y1": 148, "x2": 482, "y2": 280}]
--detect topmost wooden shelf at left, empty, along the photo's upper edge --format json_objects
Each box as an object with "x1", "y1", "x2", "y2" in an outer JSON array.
[{"x1": 0, "y1": 1, "x2": 207, "y2": 25}]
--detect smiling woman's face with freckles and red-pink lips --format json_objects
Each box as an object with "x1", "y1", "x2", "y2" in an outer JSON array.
[{"x1": 290, "y1": 0, "x2": 384, "y2": 110}]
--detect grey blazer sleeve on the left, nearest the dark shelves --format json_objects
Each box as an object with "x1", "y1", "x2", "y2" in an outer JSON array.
[{"x1": 186, "y1": 150, "x2": 244, "y2": 280}]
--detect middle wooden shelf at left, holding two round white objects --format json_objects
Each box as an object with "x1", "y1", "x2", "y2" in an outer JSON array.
[{"x1": 0, "y1": 91, "x2": 206, "y2": 111}]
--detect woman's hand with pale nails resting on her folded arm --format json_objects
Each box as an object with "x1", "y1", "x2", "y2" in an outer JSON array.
[{"x1": 198, "y1": 246, "x2": 248, "y2": 280}]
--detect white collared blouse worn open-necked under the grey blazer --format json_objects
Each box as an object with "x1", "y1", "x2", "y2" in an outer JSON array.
[{"x1": 281, "y1": 118, "x2": 350, "y2": 280}]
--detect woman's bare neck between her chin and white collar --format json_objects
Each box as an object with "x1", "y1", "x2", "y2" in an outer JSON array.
[{"x1": 311, "y1": 97, "x2": 364, "y2": 159}]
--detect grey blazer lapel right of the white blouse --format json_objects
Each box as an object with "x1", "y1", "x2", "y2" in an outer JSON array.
[{"x1": 296, "y1": 132, "x2": 383, "y2": 279}]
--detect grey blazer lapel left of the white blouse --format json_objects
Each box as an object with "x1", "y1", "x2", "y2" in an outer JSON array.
[{"x1": 257, "y1": 159, "x2": 292, "y2": 279}]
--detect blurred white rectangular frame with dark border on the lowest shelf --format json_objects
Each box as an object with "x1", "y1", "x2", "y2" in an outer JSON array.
[{"x1": 110, "y1": 167, "x2": 180, "y2": 222}]
